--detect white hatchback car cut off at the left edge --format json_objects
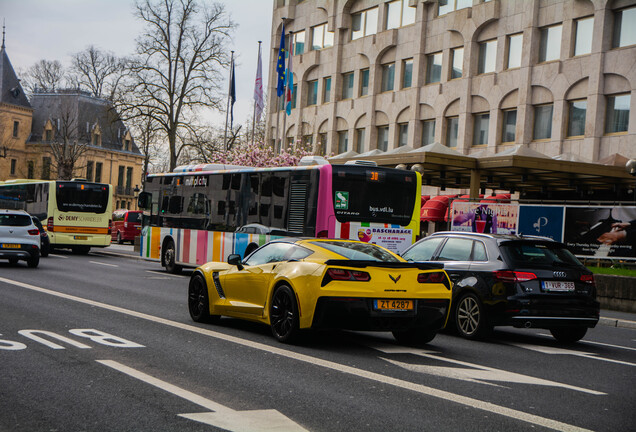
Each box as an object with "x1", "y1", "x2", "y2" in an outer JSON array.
[{"x1": 0, "y1": 210, "x2": 40, "y2": 267}]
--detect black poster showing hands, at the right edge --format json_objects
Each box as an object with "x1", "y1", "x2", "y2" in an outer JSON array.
[{"x1": 563, "y1": 206, "x2": 636, "y2": 259}]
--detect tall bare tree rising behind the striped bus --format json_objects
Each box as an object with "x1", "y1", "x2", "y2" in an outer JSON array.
[{"x1": 119, "y1": 0, "x2": 235, "y2": 170}]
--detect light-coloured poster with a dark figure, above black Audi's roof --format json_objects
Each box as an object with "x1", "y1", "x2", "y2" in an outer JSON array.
[{"x1": 451, "y1": 201, "x2": 519, "y2": 234}]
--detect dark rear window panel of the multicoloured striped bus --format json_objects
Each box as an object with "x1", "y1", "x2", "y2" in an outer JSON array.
[{"x1": 333, "y1": 165, "x2": 419, "y2": 225}]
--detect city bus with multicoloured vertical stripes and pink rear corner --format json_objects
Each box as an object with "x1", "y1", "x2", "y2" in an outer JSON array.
[{"x1": 139, "y1": 157, "x2": 422, "y2": 272}]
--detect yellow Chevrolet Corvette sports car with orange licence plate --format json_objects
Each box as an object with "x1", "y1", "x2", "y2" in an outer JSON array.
[{"x1": 188, "y1": 239, "x2": 451, "y2": 344}]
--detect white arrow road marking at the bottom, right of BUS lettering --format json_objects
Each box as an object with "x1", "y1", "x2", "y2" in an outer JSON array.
[{"x1": 97, "y1": 360, "x2": 306, "y2": 432}]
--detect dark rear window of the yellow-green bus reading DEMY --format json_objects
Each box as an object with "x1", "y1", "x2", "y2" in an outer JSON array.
[{"x1": 55, "y1": 182, "x2": 109, "y2": 213}]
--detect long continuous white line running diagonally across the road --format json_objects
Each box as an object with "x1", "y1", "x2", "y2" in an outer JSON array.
[{"x1": 0, "y1": 277, "x2": 588, "y2": 431}]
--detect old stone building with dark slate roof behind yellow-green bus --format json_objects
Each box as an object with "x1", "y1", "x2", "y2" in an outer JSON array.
[{"x1": 0, "y1": 43, "x2": 144, "y2": 209}]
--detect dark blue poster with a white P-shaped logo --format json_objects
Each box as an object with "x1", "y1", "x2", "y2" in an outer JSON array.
[{"x1": 519, "y1": 205, "x2": 565, "y2": 241}]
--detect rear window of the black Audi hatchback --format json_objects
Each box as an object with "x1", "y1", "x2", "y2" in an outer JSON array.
[{"x1": 500, "y1": 241, "x2": 583, "y2": 266}]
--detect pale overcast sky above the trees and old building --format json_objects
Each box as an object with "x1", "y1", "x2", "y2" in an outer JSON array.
[{"x1": 0, "y1": 0, "x2": 273, "y2": 126}]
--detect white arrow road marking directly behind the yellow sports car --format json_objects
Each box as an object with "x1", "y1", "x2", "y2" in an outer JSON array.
[{"x1": 370, "y1": 345, "x2": 606, "y2": 396}]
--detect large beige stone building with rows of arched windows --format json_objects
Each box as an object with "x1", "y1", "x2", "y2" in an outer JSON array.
[{"x1": 267, "y1": 0, "x2": 636, "y2": 166}]
